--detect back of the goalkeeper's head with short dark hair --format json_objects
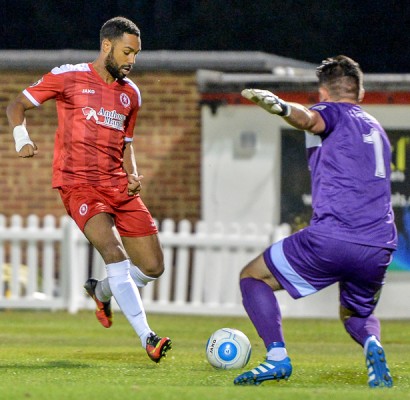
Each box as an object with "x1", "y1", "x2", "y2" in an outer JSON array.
[{"x1": 316, "y1": 55, "x2": 363, "y2": 100}]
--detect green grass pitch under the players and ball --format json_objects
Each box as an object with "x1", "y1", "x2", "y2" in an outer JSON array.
[{"x1": 0, "y1": 310, "x2": 410, "y2": 400}]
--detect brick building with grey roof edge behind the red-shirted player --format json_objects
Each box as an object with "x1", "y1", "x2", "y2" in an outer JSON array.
[{"x1": 0, "y1": 50, "x2": 318, "y2": 221}]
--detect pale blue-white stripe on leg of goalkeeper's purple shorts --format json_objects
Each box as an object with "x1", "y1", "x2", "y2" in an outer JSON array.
[{"x1": 270, "y1": 240, "x2": 317, "y2": 297}]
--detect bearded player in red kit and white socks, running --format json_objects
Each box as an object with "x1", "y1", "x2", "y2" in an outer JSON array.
[{"x1": 7, "y1": 17, "x2": 171, "y2": 362}]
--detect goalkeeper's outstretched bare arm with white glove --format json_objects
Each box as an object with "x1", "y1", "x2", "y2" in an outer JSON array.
[{"x1": 242, "y1": 89, "x2": 326, "y2": 134}]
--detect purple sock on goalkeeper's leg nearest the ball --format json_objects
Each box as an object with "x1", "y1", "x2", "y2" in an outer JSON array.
[{"x1": 240, "y1": 278, "x2": 284, "y2": 347}]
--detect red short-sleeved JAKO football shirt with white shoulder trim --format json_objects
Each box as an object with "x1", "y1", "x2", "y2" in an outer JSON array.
[{"x1": 23, "y1": 63, "x2": 141, "y2": 188}]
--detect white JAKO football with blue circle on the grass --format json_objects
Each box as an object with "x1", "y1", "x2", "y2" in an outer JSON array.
[{"x1": 206, "y1": 328, "x2": 251, "y2": 369}]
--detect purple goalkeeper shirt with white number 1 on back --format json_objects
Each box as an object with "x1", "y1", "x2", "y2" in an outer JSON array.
[{"x1": 306, "y1": 102, "x2": 397, "y2": 249}]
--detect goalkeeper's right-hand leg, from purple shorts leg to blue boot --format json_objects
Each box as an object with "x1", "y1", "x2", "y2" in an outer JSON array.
[{"x1": 339, "y1": 245, "x2": 393, "y2": 387}]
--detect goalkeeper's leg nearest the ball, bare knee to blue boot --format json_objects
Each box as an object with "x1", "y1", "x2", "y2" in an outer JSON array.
[{"x1": 234, "y1": 250, "x2": 292, "y2": 385}]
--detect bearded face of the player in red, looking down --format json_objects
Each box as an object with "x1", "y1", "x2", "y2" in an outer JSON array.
[{"x1": 105, "y1": 33, "x2": 141, "y2": 79}]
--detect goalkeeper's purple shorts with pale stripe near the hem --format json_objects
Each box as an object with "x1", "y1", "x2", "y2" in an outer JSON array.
[{"x1": 263, "y1": 228, "x2": 392, "y2": 317}]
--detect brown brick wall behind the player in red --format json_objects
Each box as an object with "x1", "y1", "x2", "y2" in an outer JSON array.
[{"x1": 0, "y1": 71, "x2": 201, "y2": 221}]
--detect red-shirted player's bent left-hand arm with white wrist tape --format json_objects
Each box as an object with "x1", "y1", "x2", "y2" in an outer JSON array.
[{"x1": 7, "y1": 93, "x2": 37, "y2": 158}]
